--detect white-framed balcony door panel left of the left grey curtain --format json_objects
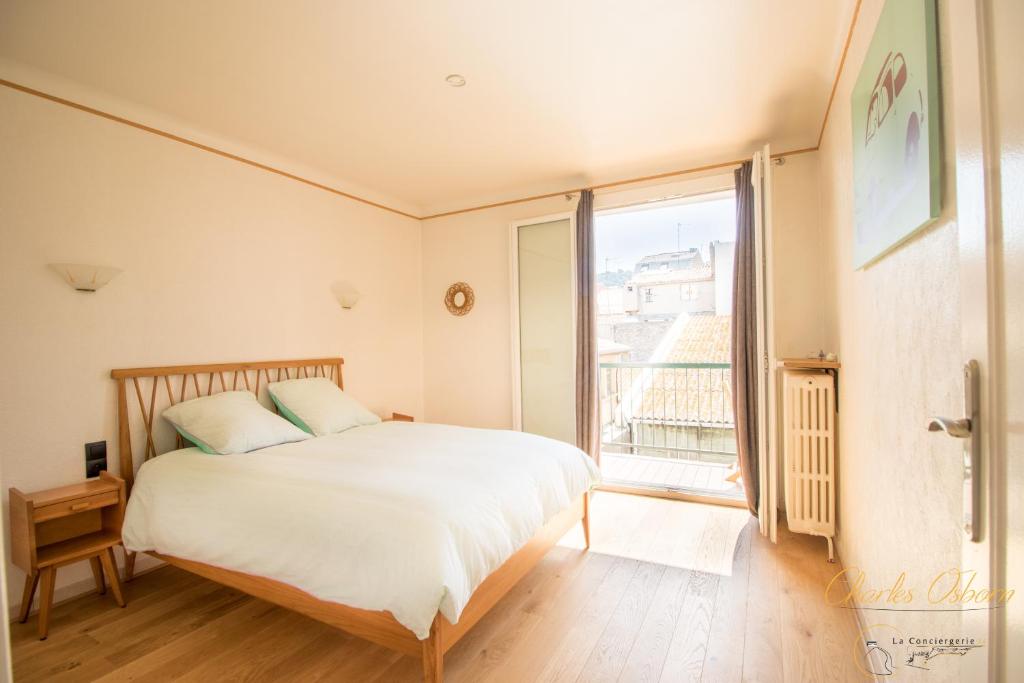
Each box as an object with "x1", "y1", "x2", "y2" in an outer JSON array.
[{"x1": 511, "y1": 215, "x2": 575, "y2": 443}]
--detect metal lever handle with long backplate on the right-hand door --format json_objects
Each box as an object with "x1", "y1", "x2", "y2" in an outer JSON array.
[{"x1": 928, "y1": 360, "x2": 982, "y2": 543}]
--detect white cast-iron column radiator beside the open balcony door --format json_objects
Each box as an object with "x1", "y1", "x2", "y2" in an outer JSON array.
[{"x1": 782, "y1": 371, "x2": 836, "y2": 562}]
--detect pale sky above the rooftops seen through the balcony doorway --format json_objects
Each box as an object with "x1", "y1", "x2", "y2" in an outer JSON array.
[{"x1": 594, "y1": 192, "x2": 736, "y2": 272}]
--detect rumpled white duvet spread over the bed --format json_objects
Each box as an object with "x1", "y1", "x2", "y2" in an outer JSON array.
[{"x1": 123, "y1": 422, "x2": 598, "y2": 639}]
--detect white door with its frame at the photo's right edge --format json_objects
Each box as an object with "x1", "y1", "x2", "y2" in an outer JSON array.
[{"x1": 937, "y1": 0, "x2": 1024, "y2": 681}]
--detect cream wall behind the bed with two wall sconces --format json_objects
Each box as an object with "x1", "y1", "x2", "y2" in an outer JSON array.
[{"x1": 0, "y1": 88, "x2": 423, "y2": 605}]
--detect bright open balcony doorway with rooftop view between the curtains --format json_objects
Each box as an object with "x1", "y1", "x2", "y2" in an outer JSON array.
[{"x1": 595, "y1": 190, "x2": 743, "y2": 501}]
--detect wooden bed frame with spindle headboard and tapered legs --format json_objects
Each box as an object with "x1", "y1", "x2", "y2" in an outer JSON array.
[{"x1": 111, "y1": 358, "x2": 590, "y2": 683}]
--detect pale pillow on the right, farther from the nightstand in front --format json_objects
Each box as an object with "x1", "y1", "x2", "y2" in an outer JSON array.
[{"x1": 267, "y1": 377, "x2": 381, "y2": 436}]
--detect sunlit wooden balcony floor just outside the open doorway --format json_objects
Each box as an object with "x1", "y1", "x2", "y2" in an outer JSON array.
[{"x1": 601, "y1": 453, "x2": 743, "y2": 498}]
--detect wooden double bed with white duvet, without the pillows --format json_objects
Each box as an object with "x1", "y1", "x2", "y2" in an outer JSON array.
[{"x1": 112, "y1": 358, "x2": 598, "y2": 682}]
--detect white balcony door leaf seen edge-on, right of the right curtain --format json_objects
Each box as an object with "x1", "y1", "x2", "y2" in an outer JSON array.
[{"x1": 751, "y1": 144, "x2": 778, "y2": 543}]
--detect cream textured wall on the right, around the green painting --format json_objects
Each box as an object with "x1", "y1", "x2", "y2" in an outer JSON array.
[{"x1": 819, "y1": 0, "x2": 963, "y2": 681}]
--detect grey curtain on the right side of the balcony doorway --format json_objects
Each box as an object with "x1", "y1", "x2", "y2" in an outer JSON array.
[{"x1": 730, "y1": 162, "x2": 760, "y2": 517}]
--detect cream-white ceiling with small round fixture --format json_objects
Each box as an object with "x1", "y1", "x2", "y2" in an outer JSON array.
[{"x1": 0, "y1": 0, "x2": 854, "y2": 213}]
